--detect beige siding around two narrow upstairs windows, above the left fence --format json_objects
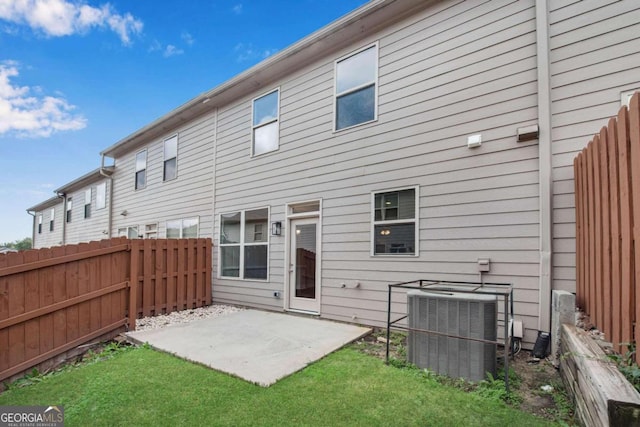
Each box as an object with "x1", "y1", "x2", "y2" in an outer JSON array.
[{"x1": 112, "y1": 113, "x2": 215, "y2": 238}]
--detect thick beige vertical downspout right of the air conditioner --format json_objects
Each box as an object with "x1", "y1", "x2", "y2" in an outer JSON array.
[{"x1": 536, "y1": 0, "x2": 553, "y2": 332}]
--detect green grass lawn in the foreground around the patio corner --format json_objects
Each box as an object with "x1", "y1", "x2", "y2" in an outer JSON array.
[{"x1": 0, "y1": 347, "x2": 552, "y2": 426}]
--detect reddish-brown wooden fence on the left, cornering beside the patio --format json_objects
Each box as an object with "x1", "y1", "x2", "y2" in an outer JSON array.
[{"x1": 0, "y1": 238, "x2": 211, "y2": 381}]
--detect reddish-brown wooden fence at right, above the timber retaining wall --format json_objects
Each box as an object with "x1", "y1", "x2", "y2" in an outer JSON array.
[{"x1": 573, "y1": 93, "x2": 640, "y2": 362}]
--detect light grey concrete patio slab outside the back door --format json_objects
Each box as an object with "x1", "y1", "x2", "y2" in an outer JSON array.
[{"x1": 127, "y1": 310, "x2": 371, "y2": 387}]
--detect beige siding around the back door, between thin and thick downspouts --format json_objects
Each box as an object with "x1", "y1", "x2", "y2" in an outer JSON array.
[{"x1": 213, "y1": 1, "x2": 539, "y2": 343}]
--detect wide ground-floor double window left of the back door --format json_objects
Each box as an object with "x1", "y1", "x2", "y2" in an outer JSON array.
[{"x1": 220, "y1": 208, "x2": 269, "y2": 280}]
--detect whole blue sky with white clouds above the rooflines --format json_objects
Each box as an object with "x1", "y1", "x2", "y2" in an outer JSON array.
[{"x1": 0, "y1": 0, "x2": 366, "y2": 243}]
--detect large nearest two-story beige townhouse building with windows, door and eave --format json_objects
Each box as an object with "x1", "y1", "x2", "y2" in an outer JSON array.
[{"x1": 27, "y1": 0, "x2": 640, "y2": 343}]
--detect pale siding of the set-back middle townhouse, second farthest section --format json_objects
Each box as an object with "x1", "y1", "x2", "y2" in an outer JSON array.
[{"x1": 65, "y1": 178, "x2": 111, "y2": 244}]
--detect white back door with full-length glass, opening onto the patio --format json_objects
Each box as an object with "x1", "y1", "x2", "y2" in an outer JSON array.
[{"x1": 289, "y1": 218, "x2": 320, "y2": 313}]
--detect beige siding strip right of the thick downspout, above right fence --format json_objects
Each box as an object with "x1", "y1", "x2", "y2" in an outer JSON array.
[{"x1": 549, "y1": 0, "x2": 640, "y2": 292}]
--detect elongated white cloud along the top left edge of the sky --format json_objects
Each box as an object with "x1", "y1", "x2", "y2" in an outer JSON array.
[{"x1": 0, "y1": 0, "x2": 143, "y2": 45}]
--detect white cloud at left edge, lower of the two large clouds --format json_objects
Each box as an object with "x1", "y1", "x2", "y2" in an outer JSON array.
[{"x1": 0, "y1": 61, "x2": 87, "y2": 138}]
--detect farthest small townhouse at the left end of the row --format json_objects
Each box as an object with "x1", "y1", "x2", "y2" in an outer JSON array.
[{"x1": 27, "y1": 196, "x2": 64, "y2": 249}]
